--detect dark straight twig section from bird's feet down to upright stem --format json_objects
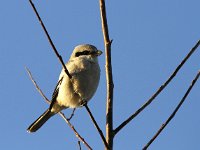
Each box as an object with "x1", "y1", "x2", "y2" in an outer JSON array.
[{"x1": 84, "y1": 103, "x2": 108, "y2": 148}]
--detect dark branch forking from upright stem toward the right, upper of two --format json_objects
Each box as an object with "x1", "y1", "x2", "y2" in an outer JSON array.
[{"x1": 114, "y1": 40, "x2": 200, "y2": 135}]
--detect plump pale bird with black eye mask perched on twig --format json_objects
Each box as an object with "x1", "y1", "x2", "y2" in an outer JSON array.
[{"x1": 27, "y1": 44, "x2": 102, "y2": 133}]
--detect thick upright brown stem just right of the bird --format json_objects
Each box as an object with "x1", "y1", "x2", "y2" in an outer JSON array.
[{"x1": 99, "y1": 0, "x2": 114, "y2": 150}]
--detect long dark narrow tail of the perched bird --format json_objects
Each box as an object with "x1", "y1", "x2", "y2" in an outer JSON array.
[{"x1": 27, "y1": 109, "x2": 55, "y2": 133}]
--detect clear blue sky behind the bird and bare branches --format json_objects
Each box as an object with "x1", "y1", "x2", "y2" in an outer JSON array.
[{"x1": 0, "y1": 0, "x2": 200, "y2": 150}]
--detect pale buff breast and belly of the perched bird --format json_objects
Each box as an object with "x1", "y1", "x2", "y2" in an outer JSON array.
[{"x1": 57, "y1": 58, "x2": 100, "y2": 108}]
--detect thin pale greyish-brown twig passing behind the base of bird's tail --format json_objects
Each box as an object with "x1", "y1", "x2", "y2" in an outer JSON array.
[{"x1": 26, "y1": 67, "x2": 92, "y2": 150}]
